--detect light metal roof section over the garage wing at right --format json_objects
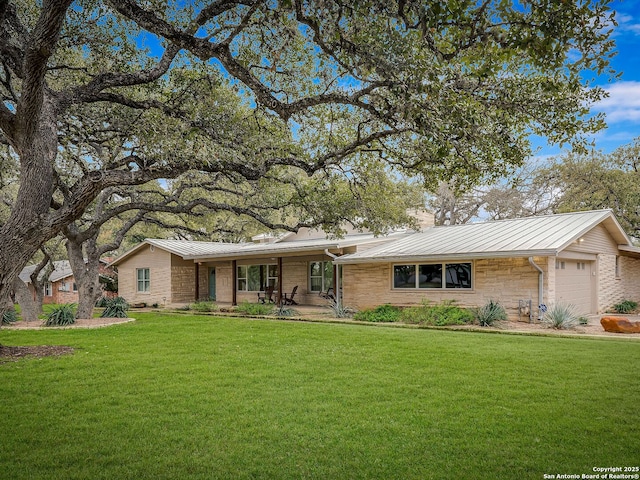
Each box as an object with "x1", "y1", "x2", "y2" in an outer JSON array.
[{"x1": 336, "y1": 210, "x2": 631, "y2": 264}]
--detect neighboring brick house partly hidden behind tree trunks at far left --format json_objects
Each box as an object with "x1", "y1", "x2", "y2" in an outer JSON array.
[{"x1": 20, "y1": 259, "x2": 113, "y2": 304}]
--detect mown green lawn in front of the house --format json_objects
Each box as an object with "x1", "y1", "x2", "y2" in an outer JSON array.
[{"x1": 0, "y1": 312, "x2": 640, "y2": 480}]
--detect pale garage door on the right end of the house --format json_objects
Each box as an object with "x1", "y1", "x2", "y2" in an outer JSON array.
[{"x1": 556, "y1": 260, "x2": 595, "y2": 314}]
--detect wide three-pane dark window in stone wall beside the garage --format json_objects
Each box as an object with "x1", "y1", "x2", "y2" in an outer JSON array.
[{"x1": 393, "y1": 263, "x2": 471, "y2": 289}]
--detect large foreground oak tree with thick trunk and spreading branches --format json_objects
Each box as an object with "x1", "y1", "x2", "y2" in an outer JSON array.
[{"x1": 0, "y1": 0, "x2": 612, "y2": 312}]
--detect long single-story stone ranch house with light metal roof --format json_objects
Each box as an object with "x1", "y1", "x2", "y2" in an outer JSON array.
[{"x1": 112, "y1": 210, "x2": 640, "y2": 317}]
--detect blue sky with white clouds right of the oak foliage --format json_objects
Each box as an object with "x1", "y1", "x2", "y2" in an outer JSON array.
[{"x1": 538, "y1": 0, "x2": 640, "y2": 157}]
